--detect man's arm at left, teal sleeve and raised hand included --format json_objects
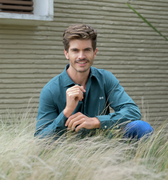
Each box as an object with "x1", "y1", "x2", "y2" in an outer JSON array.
[{"x1": 35, "y1": 85, "x2": 85, "y2": 138}]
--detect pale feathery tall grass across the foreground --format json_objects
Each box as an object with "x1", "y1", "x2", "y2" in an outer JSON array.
[{"x1": 0, "y1": 112, "x2": 168, "y2": 180}]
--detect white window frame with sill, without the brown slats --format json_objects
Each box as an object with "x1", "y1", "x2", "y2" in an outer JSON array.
[{"x1": 0, "y1": 0, "x2": 54, "y2": 25}]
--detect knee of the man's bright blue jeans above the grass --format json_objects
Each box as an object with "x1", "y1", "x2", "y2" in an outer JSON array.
[{"x1": 123, "y1": 120, "x2": 153, "y2": 139}]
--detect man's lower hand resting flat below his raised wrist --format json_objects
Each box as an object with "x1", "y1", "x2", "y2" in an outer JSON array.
[{"x1": 65, "y1": 112, "x2": 100, "y2": 132}]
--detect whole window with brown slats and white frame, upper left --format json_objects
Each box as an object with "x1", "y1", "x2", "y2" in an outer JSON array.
[{"x1": 0, "y1": 0, "x2": 54, "y2": 25}]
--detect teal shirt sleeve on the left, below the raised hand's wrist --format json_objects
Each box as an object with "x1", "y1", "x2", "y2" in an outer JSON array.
[{"x1": 34, "y1": 89, "x2": 67, "y2": 138}]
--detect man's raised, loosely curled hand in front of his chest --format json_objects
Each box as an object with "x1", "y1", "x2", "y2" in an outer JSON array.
[{"x1": 63, "y1": 85, "x2": 86, "y2": 118}]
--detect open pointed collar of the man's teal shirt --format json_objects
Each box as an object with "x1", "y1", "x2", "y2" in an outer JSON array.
[{"x1": 62, "y1": 64, "x2": 97, "y2": 87}]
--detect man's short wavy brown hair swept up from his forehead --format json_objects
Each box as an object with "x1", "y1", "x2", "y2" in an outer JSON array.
[{"x1": 63, "y1": 24, "x2": 97, "y2": 52}]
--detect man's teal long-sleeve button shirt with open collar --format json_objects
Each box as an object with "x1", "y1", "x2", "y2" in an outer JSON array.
[{"x1": 35, "y1": 65, "x2": 141, "y2": 137}]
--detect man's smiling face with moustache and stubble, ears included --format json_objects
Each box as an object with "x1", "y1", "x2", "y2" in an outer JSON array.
[{"x1": 64, "y1": 39, "x2": 97, "y2": 73}]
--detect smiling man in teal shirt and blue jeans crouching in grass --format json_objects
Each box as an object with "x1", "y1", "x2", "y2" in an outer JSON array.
[{"x1": 35, "y1": 25, "x2": 153, "y2": 138}]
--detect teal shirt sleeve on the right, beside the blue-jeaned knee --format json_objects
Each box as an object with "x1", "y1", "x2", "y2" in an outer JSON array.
[{"x1": 97, "y1": 71, "x2": 141, "y2": 129}]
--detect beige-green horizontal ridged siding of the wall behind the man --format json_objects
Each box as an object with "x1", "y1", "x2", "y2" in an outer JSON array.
[{"x1": 0, "y1": 0, "x2": 168, "y2": 125}]
